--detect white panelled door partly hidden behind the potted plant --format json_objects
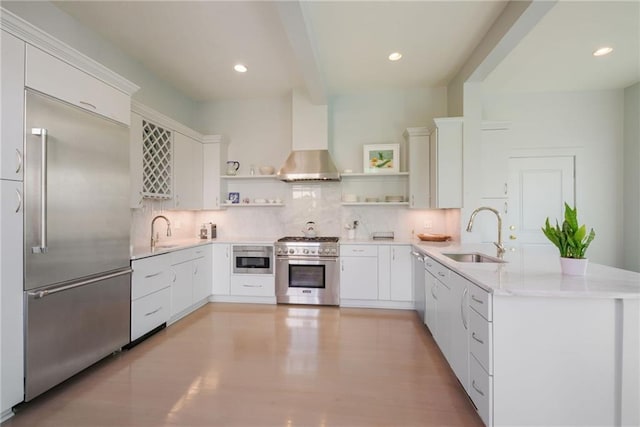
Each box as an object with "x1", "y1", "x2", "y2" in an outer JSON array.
[{"x1": 508, "y1": 156, "x2": 575, "y2": 244}]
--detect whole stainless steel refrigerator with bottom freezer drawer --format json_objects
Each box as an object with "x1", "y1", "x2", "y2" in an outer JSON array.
[{"x1": 24, "y1": 89, "x2": 131, "y2": 401}]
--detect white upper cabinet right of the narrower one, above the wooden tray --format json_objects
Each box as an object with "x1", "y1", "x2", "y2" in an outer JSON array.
[{"x1": 429, "y1": 117, "x2": 463, "y2": 209}]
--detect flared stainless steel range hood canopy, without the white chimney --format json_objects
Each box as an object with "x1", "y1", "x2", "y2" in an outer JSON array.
[{"x1": 277, "y1": 150, "x2": 340, "y2": 182}]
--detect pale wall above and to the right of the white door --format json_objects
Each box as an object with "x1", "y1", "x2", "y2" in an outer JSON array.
[{"x1": 483, "y1": 90, "x2": 624, "y2": 267}]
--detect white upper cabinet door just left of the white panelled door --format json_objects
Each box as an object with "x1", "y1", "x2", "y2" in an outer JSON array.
[{"x1": 481, "y1": 122, "x2": 510, "y2": 198}]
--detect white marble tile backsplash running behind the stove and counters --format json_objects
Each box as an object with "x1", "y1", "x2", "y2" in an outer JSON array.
[{"x1": 131, "y1": 183, "x2": 460, "y2": 246}]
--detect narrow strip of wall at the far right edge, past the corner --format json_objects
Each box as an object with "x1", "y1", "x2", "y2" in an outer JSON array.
[{"x1": 623, "y1": 83, "x2": 640, "y2": 272}]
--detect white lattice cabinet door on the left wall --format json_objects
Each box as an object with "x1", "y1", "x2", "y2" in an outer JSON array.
[{"x1": 142, "y1": 120, "x2": 173, "y2": 199}]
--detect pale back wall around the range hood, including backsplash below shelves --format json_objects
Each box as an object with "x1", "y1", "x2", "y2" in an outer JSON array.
[{"x1": 191, "y1": 88, "x2": 459, "y2": 239}]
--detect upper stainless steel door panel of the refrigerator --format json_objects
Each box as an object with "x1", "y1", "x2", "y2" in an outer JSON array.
[{"x1": 24, "y1": 90, "x2": 131, "y2": 289}]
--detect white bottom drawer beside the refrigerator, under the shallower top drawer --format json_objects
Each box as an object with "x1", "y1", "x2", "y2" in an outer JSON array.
[{"x1": 131, "y1": 288, "x2": 171, "y2": 341}]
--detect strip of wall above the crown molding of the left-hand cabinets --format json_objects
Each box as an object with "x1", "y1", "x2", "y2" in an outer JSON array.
[{"x1": 2, "y1": 1, "x2": 197, "y2": 129}]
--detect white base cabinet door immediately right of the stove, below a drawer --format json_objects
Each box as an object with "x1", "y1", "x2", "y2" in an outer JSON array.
[{"x1": 340, "y1": 245, "x2": 378, "y2": 300}]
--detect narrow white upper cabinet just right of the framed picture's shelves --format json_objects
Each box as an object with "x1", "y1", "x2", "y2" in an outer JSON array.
[{"x1": 403, "y1": 127, "x2": 431, "y2": 209}]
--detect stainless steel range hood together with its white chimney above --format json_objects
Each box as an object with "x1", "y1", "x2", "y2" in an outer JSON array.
[{"x1": 277, "y1": 90, "x2": 340, "y2": 182}]
